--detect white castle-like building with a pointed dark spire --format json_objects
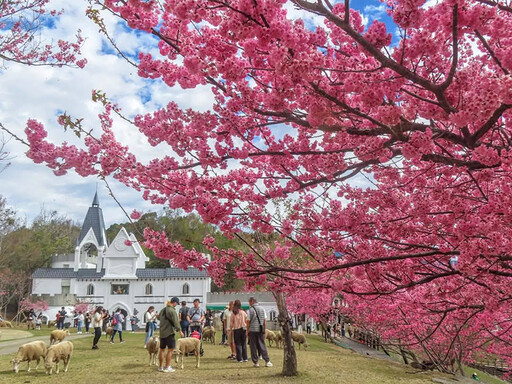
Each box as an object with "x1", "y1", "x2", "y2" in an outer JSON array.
[{"x1": 32, "y1": 194, "x2": 211, "y2": 325}]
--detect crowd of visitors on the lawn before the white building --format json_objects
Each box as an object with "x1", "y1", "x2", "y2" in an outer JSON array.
[{"x1": 23, "y1": 297, "x2": 272, "y2": 372}]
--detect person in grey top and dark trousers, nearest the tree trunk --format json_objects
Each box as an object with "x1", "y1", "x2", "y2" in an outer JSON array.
[{"x1": 247, "y1": 297, "x2": 273, "y2": 368}]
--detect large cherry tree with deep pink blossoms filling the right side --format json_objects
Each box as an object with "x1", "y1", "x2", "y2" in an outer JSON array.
[{"x1": 22, "y1": 0, "x2": 512, "y2": 374}]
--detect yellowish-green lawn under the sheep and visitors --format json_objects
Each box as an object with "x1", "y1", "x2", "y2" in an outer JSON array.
[{"x1": 0, "y1": 328, "x2": 508, "y2": 384}]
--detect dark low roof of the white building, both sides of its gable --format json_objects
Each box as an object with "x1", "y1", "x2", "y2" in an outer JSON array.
[{"x1": 32, "y1": 268, "x2": 208, "y2": 279}]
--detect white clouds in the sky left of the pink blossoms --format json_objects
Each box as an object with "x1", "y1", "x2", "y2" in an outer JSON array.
[{"x1": 0, "y1": 0, "x2": 213, "y2": 225}]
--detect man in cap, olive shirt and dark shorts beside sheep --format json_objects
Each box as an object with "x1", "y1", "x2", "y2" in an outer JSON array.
[{"x1": 158, "y1": 297, "x2": 183, "y2": 373}]
